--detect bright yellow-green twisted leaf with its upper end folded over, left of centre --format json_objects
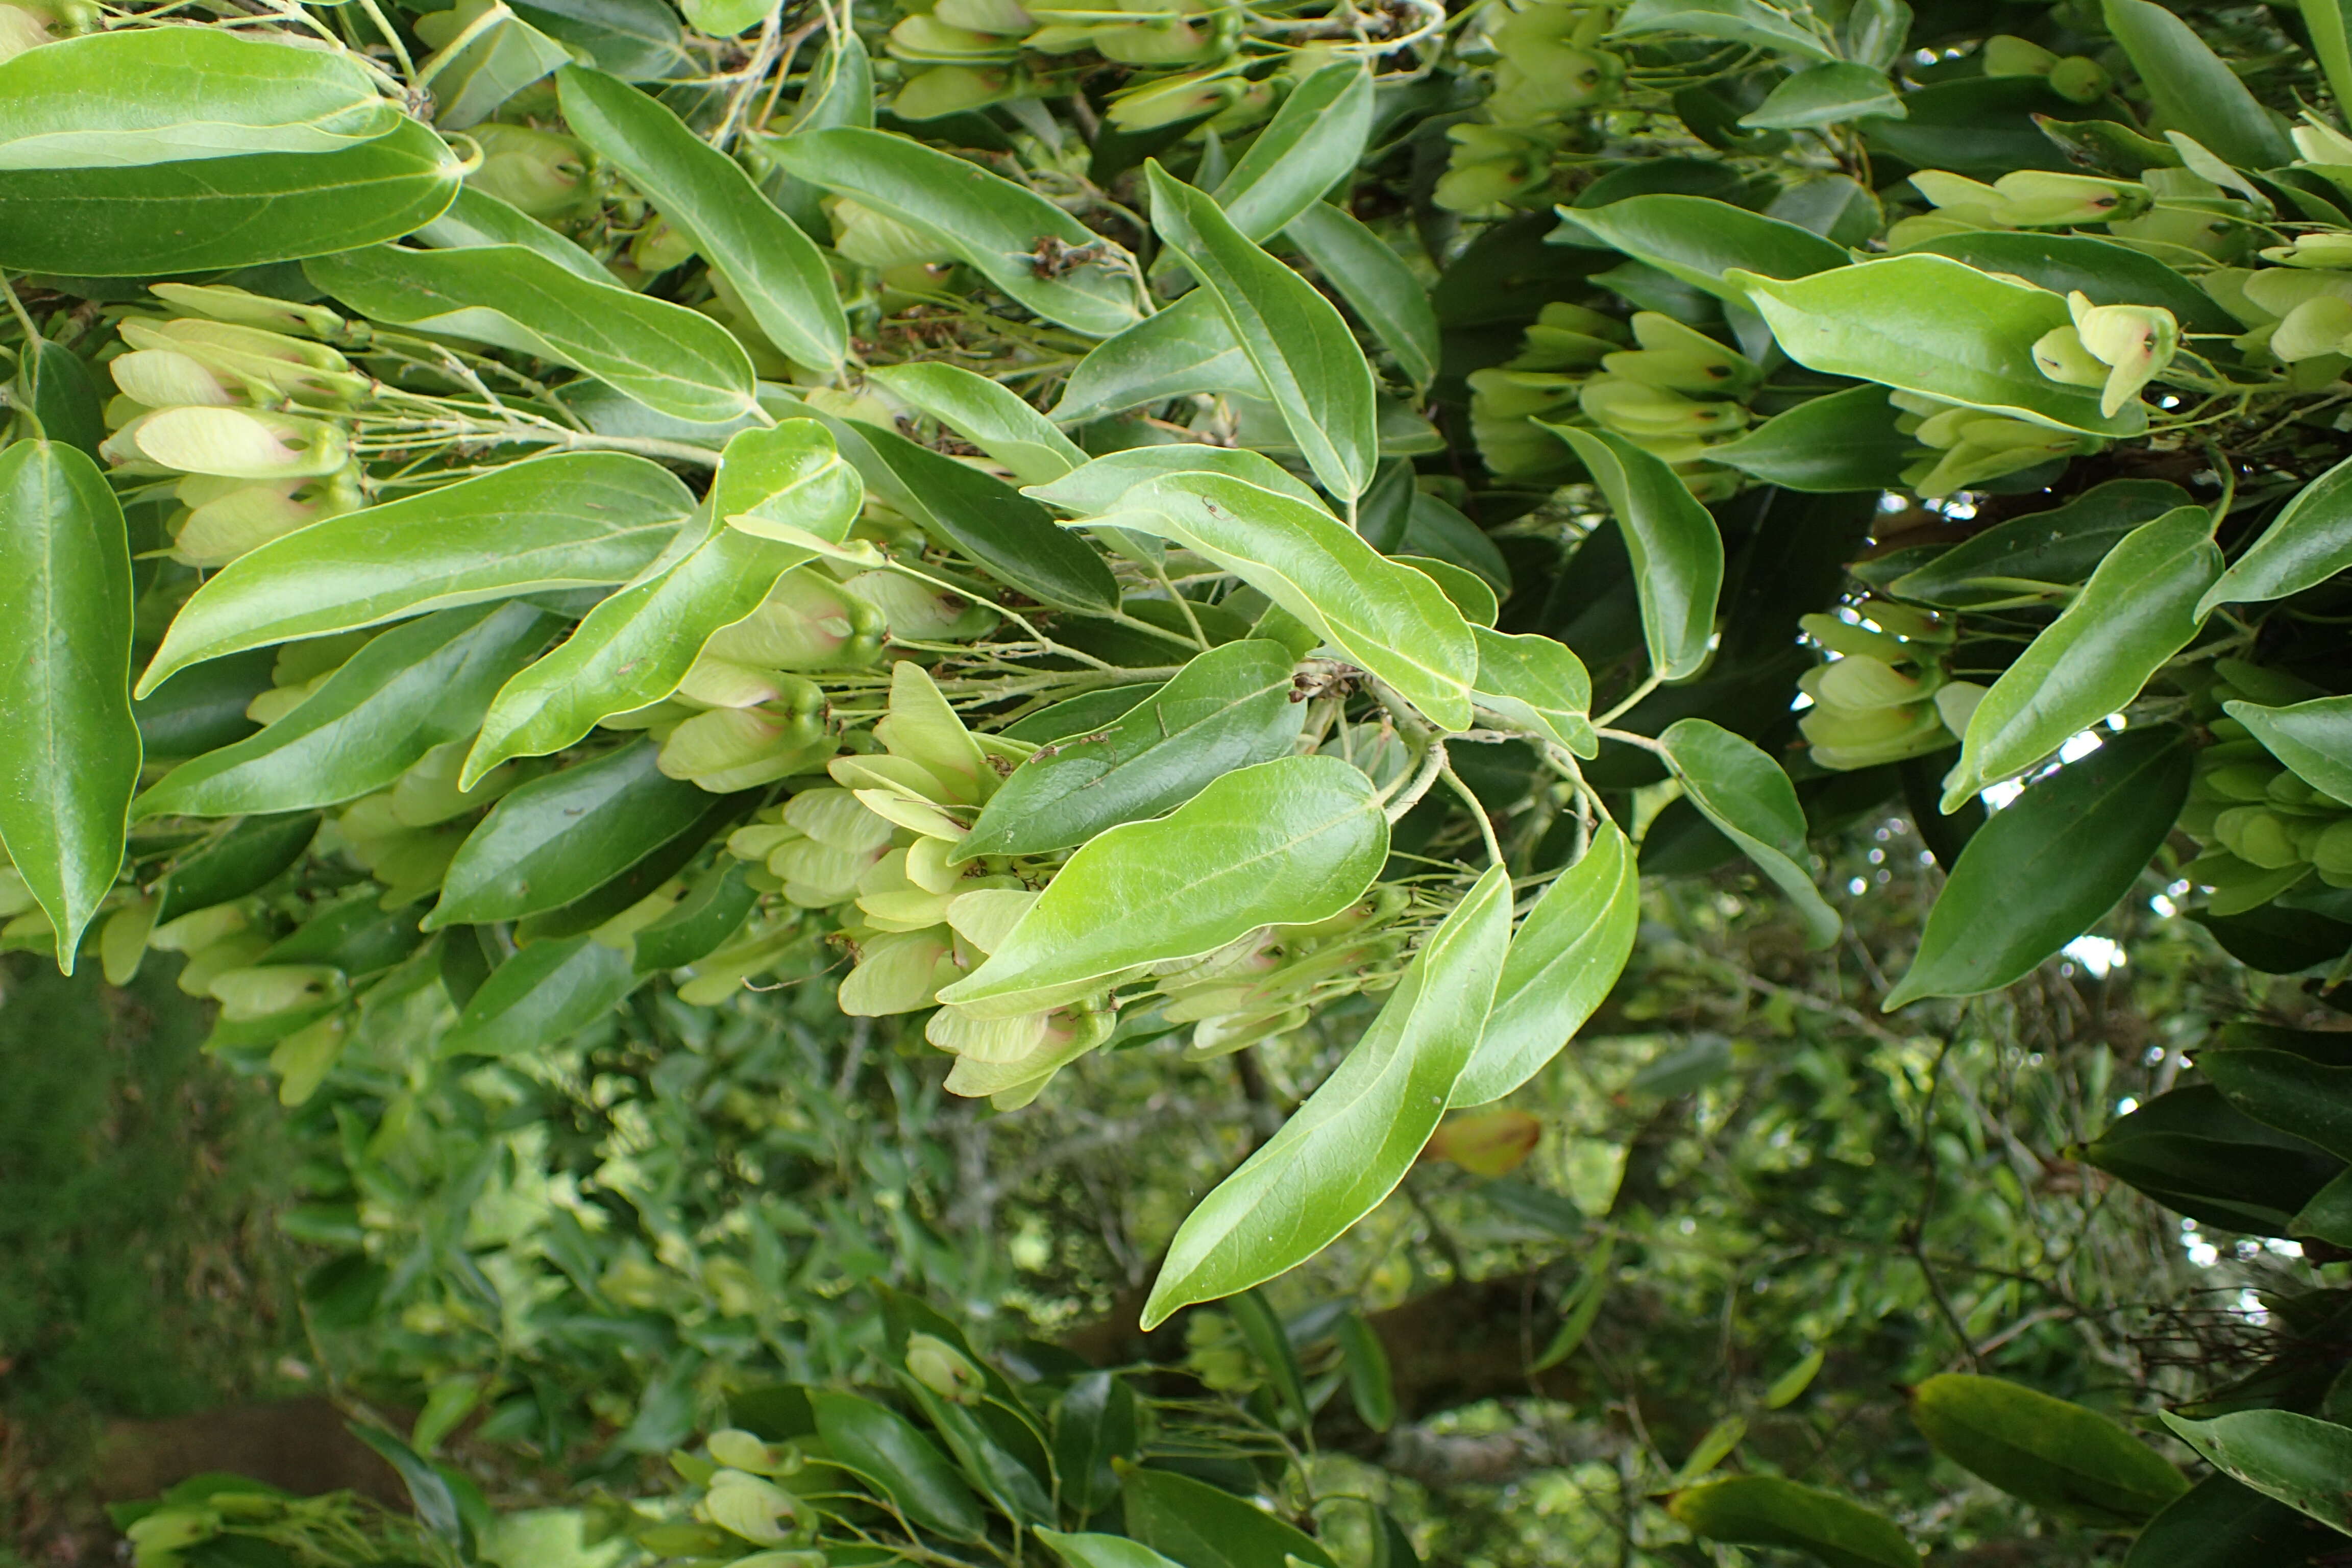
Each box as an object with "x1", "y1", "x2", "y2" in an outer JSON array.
[{"x1": 459, "y1": 419, "x2": 866, "y2": 790}]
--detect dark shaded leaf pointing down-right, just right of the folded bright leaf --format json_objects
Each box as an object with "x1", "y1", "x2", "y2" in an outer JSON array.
[{"x1": 835, "y1": 419, "x2": 1119, "y2": 614}]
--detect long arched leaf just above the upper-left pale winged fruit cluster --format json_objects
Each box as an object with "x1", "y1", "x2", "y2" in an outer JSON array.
[{"x1": 303, "y1": 244, "x2": 755, "y2": 423}]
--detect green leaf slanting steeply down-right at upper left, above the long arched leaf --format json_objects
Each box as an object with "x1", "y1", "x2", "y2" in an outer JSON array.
[{"x1": 555, "y1": 66, "x2": 849, "y2": 376}]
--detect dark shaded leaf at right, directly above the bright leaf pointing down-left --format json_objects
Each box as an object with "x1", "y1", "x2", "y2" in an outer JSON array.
[{"x1": 1889, "y1": 480, "x2": 2204, "y2": 614}]
